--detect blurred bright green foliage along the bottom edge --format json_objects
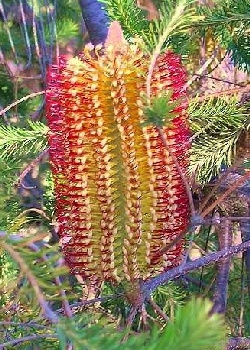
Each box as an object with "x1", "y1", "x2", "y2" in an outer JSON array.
[{"x1": 26, "y1": 299, "x2": 225, "y2": 350}]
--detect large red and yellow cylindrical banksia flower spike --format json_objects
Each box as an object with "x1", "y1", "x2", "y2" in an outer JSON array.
[{"x1": 46, "y1": 21, "x2": 189, "y2": 283}]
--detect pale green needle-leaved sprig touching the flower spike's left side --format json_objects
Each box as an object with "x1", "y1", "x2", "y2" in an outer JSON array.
[{"x1": 0, "y1": 121, "x2": 48, "y2": 162}]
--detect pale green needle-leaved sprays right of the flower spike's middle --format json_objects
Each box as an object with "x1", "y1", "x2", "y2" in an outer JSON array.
[{"x1": 188, "y1": 98, "x2": 249, "y2": 183}]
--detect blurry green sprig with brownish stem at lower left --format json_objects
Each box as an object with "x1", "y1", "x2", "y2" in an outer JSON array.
[{"x1": 0, "y1": 235, "x2": 70, "y2": 312}]
